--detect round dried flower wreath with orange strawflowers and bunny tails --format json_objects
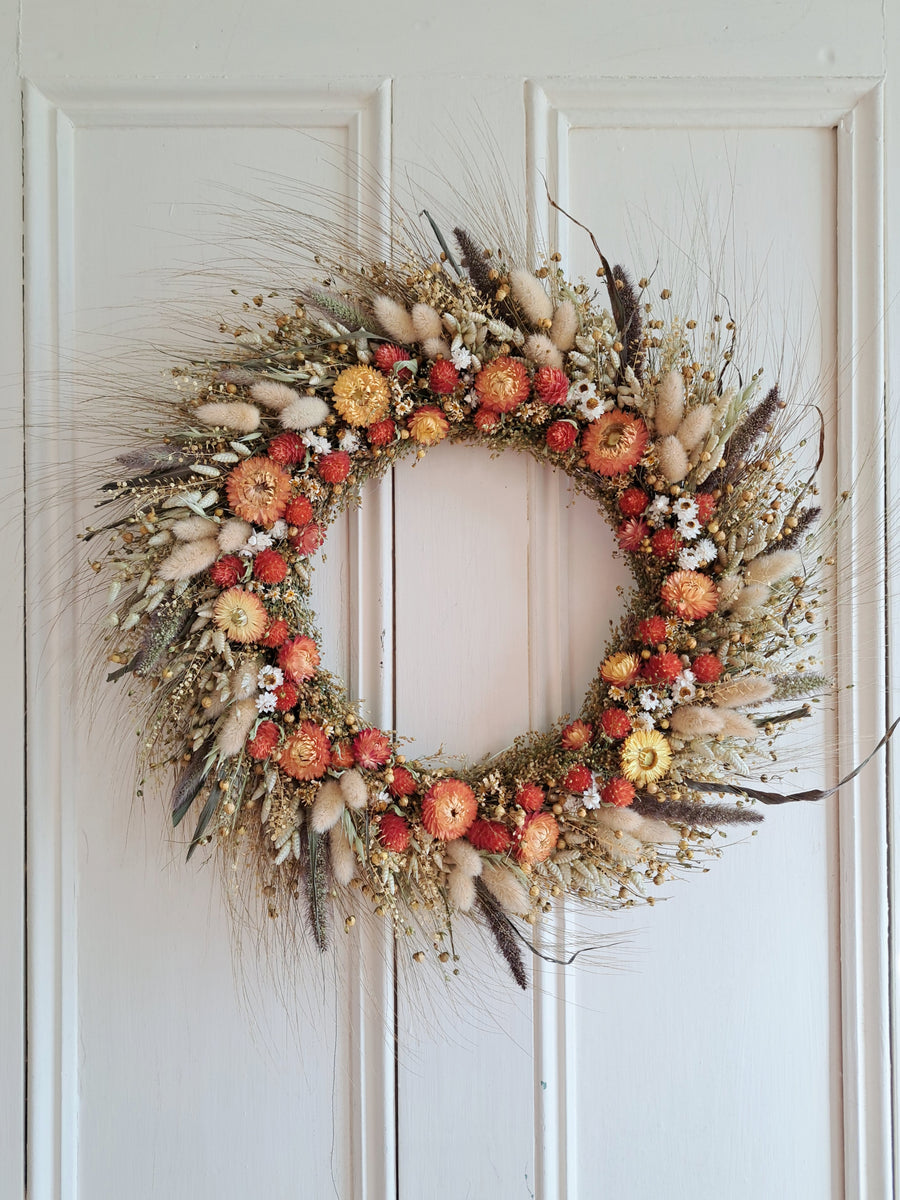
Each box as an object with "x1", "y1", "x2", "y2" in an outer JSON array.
[{"x1": 88, "y1": 211, "x2": 826, "y2": 985}]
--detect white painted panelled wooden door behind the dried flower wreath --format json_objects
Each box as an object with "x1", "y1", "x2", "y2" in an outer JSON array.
[{"x1": 10, "y1": 0, "x2": 898, "y2": 1200}]
